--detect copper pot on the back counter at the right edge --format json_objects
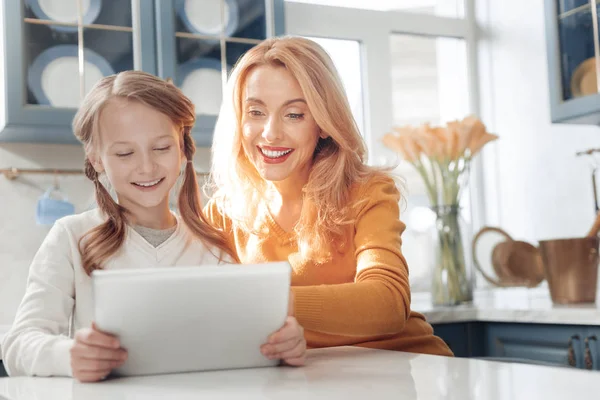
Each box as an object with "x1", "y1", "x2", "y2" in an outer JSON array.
[{"x1": 539, "y1": 236, "x2": 599, "y2": 304}]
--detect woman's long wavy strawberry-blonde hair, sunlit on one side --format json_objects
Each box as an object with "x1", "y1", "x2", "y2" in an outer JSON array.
[{"x1": 211, "y1": 37, "x2": 388, "y2": 263}]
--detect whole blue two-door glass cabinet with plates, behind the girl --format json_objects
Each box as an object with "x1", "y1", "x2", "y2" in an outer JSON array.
[{"x1": 0, "y1": 0, "x2": 284, "y2": 146}]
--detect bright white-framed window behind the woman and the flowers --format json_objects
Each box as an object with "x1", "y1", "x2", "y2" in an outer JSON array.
[{"x1": 285, "y1": 0, "x2": 483, "y2": 292}]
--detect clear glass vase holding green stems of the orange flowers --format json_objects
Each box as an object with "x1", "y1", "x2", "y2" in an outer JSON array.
[{"x1": 431, "y1": 204, "x2": 473, "y2": 306}]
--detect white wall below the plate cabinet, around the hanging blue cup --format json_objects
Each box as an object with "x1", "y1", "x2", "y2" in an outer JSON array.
[{"x1": 0, "y1": 144, "x2": 210, "y2": 331}]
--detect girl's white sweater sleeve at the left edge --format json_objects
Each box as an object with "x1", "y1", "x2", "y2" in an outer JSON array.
[{"x1": 2, "y1": 221, "x2": 75, "y2": 376}]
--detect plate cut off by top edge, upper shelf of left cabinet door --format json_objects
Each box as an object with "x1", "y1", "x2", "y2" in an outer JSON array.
[{"x1": 27, "y1": 0, "x2": 102, "y2": 32}]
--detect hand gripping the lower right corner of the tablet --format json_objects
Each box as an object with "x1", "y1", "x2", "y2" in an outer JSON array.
[{"x1": 260, "y1": 290, "x2": 306, "y2": 366}]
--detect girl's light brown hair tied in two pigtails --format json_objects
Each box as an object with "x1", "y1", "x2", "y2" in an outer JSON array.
[{"x1": 73, "y1": 71, "x2": 236, "y2": 275}]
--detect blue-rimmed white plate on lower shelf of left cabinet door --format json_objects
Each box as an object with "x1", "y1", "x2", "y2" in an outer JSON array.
[{"x1": 27, "y1": 45, "x2": 114, "y2": 108}]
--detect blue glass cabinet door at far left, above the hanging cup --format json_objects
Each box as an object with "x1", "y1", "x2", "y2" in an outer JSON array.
[{"x1": 0, "y1": 0, "x2": 156, "y2": 143}]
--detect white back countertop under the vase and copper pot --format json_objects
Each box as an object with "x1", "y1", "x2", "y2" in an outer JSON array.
[{"x1": 411, "y1": 285, "x2": 600, "y2": 326}]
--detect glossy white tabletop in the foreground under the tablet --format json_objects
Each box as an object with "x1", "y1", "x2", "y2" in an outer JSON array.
[{"x1": 0, "y1": 347, "x2": 600, "y2": 400}]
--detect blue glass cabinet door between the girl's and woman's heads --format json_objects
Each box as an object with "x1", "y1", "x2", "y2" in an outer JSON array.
[{"x1": 155, "y1": 0, "x2": 284, "y2": 146}]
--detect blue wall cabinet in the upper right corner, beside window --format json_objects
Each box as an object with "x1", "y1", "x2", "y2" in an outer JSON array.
[{"x1": 544, "y1": 0, "x2": 600, "y2": 125}]
